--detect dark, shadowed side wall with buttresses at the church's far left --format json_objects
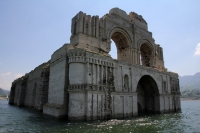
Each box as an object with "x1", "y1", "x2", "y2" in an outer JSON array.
[{"x1": 9, "y1": 62, "x2": 49, "y2": 110}]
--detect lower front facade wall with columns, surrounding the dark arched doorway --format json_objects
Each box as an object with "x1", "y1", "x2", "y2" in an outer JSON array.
[{"x1": 68, "y1": 49, "x2": 180, "y2": 120}]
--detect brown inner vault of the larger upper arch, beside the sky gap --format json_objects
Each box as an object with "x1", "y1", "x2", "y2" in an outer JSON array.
[{"x1": 111, "y1": 31, "x2": 130, "y2": 61}]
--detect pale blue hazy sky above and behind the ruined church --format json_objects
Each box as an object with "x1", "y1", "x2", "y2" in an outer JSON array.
[{"x1": 0, "y1": 0, "x2": 200, "y2": 90}]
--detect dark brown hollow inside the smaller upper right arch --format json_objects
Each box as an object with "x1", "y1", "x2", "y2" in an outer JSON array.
[{"x1": 140, "y1": 43, "x2": 152, "y2": 67}]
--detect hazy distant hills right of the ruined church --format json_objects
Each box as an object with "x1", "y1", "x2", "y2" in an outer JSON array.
[{"x1": 179, "y1": 72, "x2": 200, "y2": 99}]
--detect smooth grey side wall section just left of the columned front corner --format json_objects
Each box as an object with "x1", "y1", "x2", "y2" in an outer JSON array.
[{"x1": 43, "y1": 44, "x2": 69, "y2": 117}]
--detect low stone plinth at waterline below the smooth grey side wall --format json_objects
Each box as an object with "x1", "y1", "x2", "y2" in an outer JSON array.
[{"x1": 43, "y1": 103, "x2": 67, "y2": 118}]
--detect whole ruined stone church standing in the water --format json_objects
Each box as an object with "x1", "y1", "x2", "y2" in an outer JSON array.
[{"x1": 9, "y1": 8, "x2": 181, "y2": 120}]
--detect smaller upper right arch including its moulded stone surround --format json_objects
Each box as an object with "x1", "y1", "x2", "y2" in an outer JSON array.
[{"x1": 138, "y1": 39, "x2": 155, "y2": 67}]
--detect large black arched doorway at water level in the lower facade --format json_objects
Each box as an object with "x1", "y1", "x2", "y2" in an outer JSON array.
[{"x1": 137, "y1": 75, "x2": 160, "y2": 114}]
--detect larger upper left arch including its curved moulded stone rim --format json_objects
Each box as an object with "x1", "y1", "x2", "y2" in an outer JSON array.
[{"x1": 107, "y1": 27, "x2": 132, "y2": 61}]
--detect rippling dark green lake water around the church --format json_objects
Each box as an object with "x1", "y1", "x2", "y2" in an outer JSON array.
[{"x1": 0, "y1": 100, "x2": 200, "y2": 133}]
